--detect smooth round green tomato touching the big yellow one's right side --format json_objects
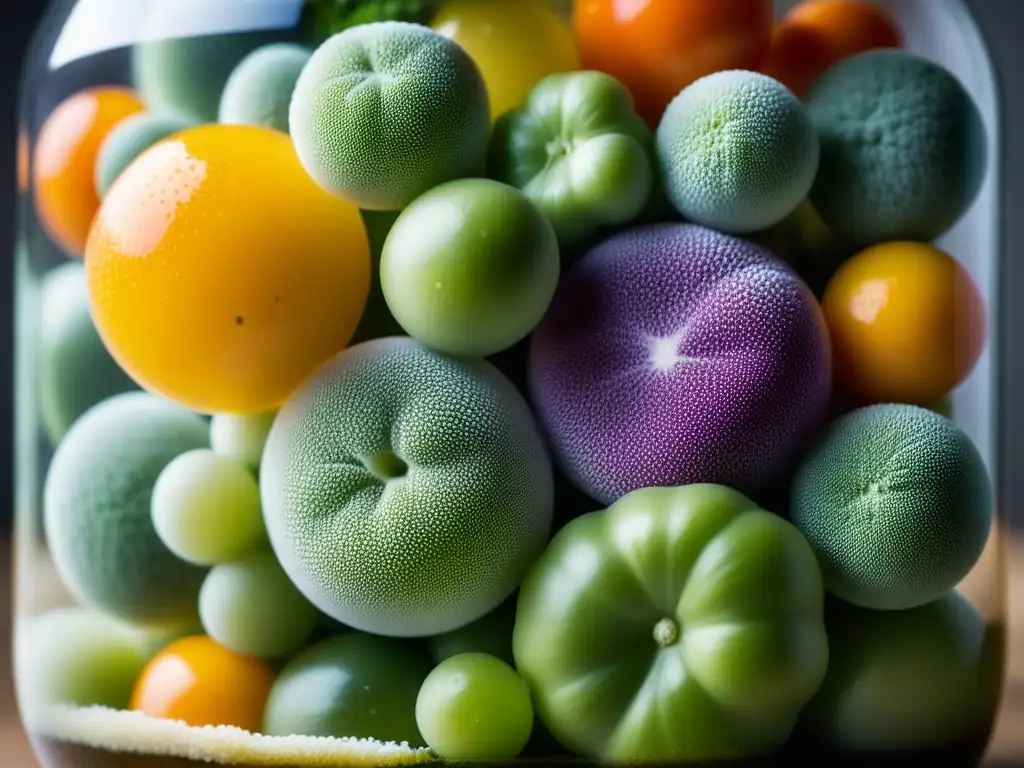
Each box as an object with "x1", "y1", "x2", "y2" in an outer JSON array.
[{"x1": 380, "y1": 178, "x2": 560, "y2": 356}]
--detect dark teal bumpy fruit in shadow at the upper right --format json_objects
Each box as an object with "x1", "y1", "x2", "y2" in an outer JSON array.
[{"x1": 805, "y1": 49, "x2": 988, "y2": 246}]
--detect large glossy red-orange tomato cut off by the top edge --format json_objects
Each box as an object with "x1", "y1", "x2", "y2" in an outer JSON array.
[{"x1": 572, "y1": 0, "x2": 772, "y2": 127}]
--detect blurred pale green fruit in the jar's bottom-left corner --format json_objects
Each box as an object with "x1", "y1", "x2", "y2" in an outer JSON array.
[{"x1": 14, "y1": 607, "x2": 146, "y2": 722}]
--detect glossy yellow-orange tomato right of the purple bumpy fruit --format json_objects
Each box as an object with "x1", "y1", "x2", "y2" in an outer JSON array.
[{"x1": 822, "y1": 242, "x2": 985, "y2": 406}]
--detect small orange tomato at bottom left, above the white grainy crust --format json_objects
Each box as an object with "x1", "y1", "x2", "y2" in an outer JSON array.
[{"x1": 130, "y1": 635, "x2": 274, "y2": 733}]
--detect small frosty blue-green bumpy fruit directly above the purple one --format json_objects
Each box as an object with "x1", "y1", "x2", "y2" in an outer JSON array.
[{"x1": 657, "y1": 71, "x2": 819, "y2": 233}]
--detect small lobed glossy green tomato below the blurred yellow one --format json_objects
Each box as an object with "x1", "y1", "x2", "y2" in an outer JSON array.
[{"x1": 487, "y1": 72, "x2": 654, "y2": 246}]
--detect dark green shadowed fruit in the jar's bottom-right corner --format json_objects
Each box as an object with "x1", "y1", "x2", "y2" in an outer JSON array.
[{"x1": 804, "y1": 592, "x2": 999, "y2": 752}]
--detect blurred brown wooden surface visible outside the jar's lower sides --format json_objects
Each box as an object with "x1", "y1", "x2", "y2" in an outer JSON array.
[{"x1": 0, "y1": 538, "x2": 1024, "y2": 768}]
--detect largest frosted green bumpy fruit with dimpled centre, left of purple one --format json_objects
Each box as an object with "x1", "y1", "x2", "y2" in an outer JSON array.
[{"x1": 260, "y1": 338, "x2": 553, "y2": 637}]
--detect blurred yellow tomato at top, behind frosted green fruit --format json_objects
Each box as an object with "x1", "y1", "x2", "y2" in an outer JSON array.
[{"x1": 432, "y1": 0, "x2": 580, "y2": 120}]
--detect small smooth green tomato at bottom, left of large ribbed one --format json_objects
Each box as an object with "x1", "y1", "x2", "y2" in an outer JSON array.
[{"x1": 416, "y1": 653, "x2": 534, "y2": 760}]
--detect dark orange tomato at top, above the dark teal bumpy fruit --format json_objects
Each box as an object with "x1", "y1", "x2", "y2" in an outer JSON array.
[{"x1": 762, "y1": 0, "x2": 903, "y2": 96}]
